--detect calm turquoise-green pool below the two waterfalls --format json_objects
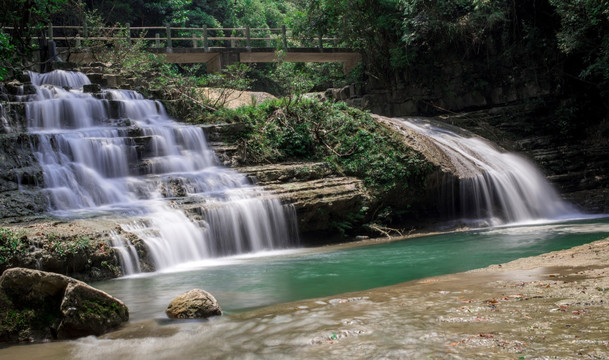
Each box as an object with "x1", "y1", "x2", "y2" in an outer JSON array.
[{"x1": 94, "y1": 219, "x2": 609, "y2": 320}]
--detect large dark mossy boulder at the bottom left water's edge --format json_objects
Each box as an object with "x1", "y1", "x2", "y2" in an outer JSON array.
[{"x1": 0, "y1": 268, "x2": 129, "y2": 341}]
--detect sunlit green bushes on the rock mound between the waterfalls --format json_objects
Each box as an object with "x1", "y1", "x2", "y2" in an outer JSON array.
[{"x1": 229, "y1": 99, "x2": 427, "y2": 192}]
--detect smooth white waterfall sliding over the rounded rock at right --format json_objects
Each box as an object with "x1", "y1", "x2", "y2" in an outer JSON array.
[{"x1": 401, "y1": 119, "x2": 581, "y2": 225}]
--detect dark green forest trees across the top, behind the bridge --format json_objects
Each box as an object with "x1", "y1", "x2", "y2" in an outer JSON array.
[{"x1": 0, "y1": 0, "x2": 609, "y2": 112}]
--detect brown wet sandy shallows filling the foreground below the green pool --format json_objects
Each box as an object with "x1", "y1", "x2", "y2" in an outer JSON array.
[{"x1": 0, "y1": 239, "x2": 609, "y2": 360}]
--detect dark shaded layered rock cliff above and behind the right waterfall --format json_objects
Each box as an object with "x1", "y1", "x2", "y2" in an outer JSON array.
[{"x1": 325, "y1": 76, "x2": 609, "y2": 213}]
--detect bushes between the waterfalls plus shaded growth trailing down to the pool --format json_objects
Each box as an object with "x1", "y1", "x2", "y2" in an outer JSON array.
[{"x1": 212, "y1": 98, "x2": 433, "y2": 233}]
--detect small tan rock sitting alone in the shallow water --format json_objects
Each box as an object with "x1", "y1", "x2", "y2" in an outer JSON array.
[{"x1": 165, "y1": 289, "x2": 222, "y2": 319}]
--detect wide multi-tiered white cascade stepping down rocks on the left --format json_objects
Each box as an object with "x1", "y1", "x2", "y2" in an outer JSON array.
[{"x1": 26, "y1": 71, "x2": 298, "y2": 273}]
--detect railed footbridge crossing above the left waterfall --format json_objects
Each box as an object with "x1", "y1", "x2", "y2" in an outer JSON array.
[{"x1": 42, "y1": 25, "x2": 361, "y2": 74}]
